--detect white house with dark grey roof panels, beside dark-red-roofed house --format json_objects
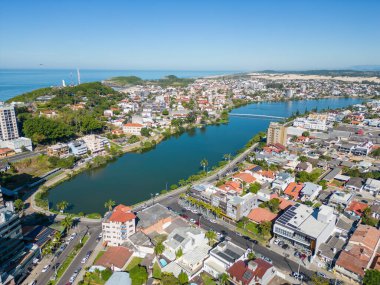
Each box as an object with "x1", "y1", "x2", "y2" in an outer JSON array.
[{"x1": 203, "y1": 241, "x2": 246, "y2": 278}]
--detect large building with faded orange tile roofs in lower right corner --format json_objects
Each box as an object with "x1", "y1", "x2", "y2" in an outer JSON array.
[{"x1": 335, "y1": 225, "x2": 380, "y2": 282}]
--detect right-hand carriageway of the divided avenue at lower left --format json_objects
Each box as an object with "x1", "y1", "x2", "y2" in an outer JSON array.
[{"x1": 57, "y1": 225, "x2": 102, "y2": 285}]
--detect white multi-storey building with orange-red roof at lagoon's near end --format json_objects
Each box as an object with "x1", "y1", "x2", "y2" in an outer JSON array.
[{"x1": 102, "y1": 204, "x2": 136, "y2": 246}]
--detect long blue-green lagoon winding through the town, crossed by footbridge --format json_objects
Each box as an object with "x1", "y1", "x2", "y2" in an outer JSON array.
[{"x1": 49, "y1": 98, "x2": 362, "y2": 213}]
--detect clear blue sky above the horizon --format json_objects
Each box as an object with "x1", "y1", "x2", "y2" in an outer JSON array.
[{"x1": 0, "y1": 0, "x2": 380, "y2": 70}]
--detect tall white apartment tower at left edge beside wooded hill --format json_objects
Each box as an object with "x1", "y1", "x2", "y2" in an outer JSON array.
[{"x1": 0, "y1": 104, "x2": 19, "y2": 141}]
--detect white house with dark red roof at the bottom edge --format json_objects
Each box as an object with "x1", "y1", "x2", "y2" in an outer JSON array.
[{"x1": 227, "y1": 258, "x2": 276, "y2": 285}]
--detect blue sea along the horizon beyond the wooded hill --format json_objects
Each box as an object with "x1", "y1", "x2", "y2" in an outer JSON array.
[{"x1": 0, "y1": 69, "x2": 236, "y2": 101}]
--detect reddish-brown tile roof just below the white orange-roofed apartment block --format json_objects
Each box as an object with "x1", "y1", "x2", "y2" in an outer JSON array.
[{"x1": 95, "y1": 246, "x2": 133, "y2": 269}]
